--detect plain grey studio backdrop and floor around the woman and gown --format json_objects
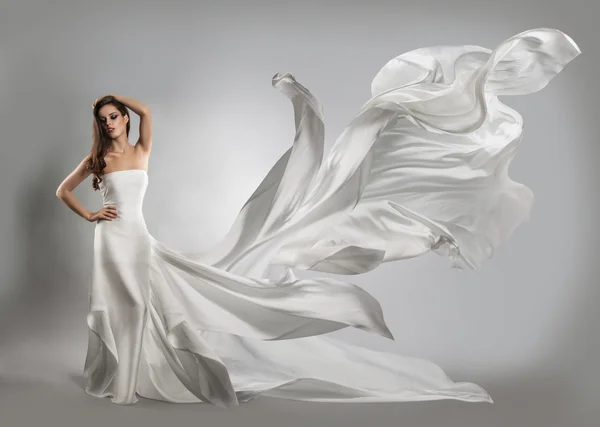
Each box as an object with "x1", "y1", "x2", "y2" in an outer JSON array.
[{"x1": 0, "y1": 0, "x2": 600, "y2": 427}]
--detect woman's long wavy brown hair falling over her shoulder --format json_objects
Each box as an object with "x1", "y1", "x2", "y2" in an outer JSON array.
[{"x1": 86, "y1": 95, "x2": 131, "y2": 190}]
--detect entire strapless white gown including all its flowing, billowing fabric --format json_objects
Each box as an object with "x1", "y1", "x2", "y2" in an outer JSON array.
[{"x1": 84, "y1": 28, "x2": 581, "y2": 407}]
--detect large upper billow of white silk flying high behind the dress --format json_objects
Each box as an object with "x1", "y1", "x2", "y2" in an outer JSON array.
[{"x1": 192, "y1": 28, "x2": 581, "y2": 277}]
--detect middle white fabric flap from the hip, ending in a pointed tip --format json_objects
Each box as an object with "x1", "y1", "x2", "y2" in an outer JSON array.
[{"x1": 152, "y1": 238, "x2": 393, "y2": 340}]
